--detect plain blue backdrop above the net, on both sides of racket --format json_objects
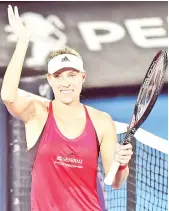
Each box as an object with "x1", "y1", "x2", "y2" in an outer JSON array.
[{"x1": 83, "y1": 94, "x2": 168, "y2": 139}]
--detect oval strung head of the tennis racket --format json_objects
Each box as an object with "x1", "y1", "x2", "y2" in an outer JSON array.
[{"x1": 134, "y1": 51, "x2": 168, "y2": 125}]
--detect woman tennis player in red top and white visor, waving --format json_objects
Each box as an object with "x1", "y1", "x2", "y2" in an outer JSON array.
[{"x1": 1, "y1": 5, "x2": 133, "y2": 211}]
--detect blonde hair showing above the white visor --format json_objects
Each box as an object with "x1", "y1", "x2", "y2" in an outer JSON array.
[{"x1": 47, "y1": 47, "x2": 81, "y2": 62}]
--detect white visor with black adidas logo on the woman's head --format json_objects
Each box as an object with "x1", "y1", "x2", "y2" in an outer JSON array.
[{"x1": 48, "y1": 54, "x2": 85, "y2": 74}]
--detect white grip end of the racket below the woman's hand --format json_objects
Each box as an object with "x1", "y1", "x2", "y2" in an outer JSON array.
[{"x1": 104, "y1": 162, "x2": 120, "y2": 185}]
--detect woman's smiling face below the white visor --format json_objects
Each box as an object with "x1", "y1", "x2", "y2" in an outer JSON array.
[{"x1": 47, "y1": 69, "x2": 86, "y2": 105}]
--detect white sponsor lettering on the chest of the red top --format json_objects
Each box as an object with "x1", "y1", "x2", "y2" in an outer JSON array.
[{"x1": 54, "y1": 153, "x2": 83, "y2": 168}]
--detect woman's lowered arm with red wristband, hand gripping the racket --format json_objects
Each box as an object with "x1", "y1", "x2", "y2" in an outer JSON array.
[{"x1": 100, "y1": 114, "x2": 132, "y2": 189}]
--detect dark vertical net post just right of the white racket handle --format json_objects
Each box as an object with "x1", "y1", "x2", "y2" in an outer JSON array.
[{"x1": 127, "y1": 137, "x2": 136, "y2": 211}]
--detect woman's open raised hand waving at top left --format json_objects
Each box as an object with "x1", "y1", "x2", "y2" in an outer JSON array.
[{"x1": 8, "y1": 5, "x2": 30, "y2": 43}]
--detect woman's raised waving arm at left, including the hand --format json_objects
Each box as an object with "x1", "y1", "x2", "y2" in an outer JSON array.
[{"x1": 1, "y1": 6, "x2": 34, "y2": 122}]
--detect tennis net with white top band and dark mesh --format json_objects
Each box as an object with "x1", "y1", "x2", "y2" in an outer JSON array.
[{"x1": 98, "y1": 122, "x2": 168, "y2": 211}]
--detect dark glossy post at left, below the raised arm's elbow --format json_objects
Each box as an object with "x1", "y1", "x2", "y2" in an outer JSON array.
[{"x1": 8, "y1": 114, "x2": 30, "y2": 211}]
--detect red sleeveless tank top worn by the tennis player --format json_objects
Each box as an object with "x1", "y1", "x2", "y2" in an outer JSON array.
[{"x1": 31, "y1": 102, "x2": 101, "y2": 211}]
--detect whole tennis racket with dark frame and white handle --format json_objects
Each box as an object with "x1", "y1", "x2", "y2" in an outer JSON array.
[{"x1": 104, "y1": 50, "x2": 168, "y2": 185}]
